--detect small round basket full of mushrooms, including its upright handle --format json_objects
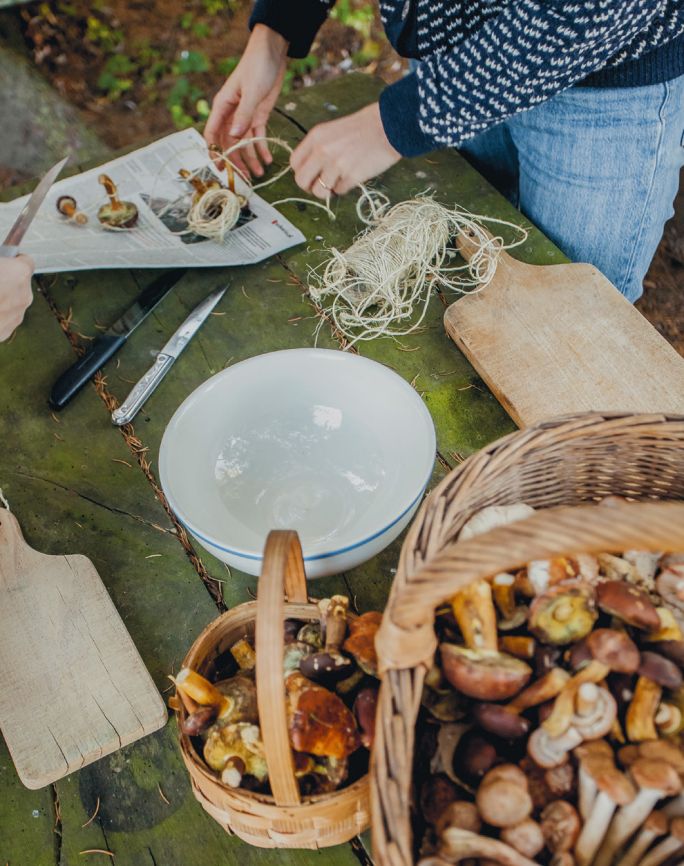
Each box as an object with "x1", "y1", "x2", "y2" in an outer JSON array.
[{"x1": 168, "y1": 532, "x2": 381, "y2": 848}]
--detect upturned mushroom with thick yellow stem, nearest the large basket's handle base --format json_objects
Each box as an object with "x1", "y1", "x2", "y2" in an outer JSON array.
[{"x1": 440, "y1": 580, "x2": 532, "y2": 702}]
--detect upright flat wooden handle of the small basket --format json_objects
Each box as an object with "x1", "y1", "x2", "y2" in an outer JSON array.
[{"x1": 254, "y1": 530, "x2": 308, "y2": 806}]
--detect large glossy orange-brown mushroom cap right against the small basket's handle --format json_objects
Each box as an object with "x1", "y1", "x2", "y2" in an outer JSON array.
[{"x1": 285, "y1": 672, "x2": 361, "y2": 759}]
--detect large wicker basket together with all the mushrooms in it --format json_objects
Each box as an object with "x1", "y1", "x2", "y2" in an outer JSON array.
[{"x1": 371, "y1": 414, "x2": 684, "y2": 866}]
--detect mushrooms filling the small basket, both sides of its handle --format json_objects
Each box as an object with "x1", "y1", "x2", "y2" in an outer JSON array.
[{"x1": 174, "y1": 595, "x2": 381, "y2": 795}]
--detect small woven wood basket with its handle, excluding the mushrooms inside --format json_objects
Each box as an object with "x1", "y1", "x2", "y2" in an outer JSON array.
[{"x1": 178, "y1": 531, "x2": 370, "y2": 849}]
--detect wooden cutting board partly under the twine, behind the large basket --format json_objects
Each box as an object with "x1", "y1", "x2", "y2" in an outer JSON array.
[{"x1": 444, "y1": 231, "x2": 684, "y2": 427}]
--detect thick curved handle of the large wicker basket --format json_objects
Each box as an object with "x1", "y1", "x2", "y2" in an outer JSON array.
[{"x1": 376, "y1": 502, "x2": 684, "y2": 671}]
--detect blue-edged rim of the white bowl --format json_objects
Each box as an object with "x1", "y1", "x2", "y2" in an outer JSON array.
[{"x1": 158, "y1": 347, "x2": 437, "y2": 562}]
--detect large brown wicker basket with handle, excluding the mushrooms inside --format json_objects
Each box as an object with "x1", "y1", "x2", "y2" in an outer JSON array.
[{"x1": 371, "y1": 414, "x2": 684, "y2": 866}]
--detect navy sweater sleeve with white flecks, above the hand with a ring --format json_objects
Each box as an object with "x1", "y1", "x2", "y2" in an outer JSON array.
[{"x1": 380, "y1": 0, "x2": 658, "y2": 156}]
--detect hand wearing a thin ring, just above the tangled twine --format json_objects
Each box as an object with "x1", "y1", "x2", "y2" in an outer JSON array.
[{"x1": 290, "y1": 102, "x2": 401, "y2": 199}]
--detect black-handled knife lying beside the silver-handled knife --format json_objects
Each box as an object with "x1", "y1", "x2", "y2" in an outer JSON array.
[{"x1": 48, "y1": 268, "x2": 187, "y2": 409}]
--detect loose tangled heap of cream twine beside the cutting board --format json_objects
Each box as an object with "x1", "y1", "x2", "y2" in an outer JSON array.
[{"x1": 309, "y1": 194, "x2": 527, "y2": 346}]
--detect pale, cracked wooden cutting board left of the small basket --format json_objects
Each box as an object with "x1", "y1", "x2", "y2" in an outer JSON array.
[{"x1": 0, "y1": 509, "x2": 166, "y2": 788}]
